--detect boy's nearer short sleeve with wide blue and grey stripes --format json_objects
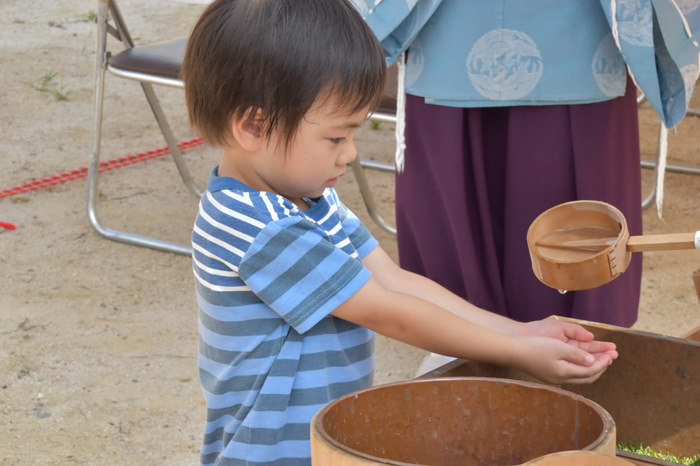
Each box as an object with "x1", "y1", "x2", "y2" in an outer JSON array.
[{"x1": 239, "y1": 217, "x2": 371, "y2": 333}]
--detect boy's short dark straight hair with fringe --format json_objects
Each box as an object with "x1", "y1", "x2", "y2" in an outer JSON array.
[{"x1": 182, "y1": 0, "x2": 386, "y2": 146}]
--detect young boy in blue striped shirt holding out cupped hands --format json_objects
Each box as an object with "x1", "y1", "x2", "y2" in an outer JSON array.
[{"x1": 183, "y1": 0, "x2": 617, "y2": 465}]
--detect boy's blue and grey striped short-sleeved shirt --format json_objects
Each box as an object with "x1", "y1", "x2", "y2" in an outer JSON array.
[{"x1": 192, "y1": 169, "x2": 377, "y2": 466}]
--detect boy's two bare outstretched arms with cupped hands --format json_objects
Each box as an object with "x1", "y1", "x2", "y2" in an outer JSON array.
[{"x1": 333, "y1": 248, "x2": 613, "y2": 383}]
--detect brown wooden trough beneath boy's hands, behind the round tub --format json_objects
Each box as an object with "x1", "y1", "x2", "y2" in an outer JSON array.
[{"x1": 425, "y1": 317, "x2": 700, "y2": 464}]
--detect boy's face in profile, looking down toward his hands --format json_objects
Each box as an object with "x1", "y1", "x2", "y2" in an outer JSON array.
[{"x1": 256, "y1": 98, "x2": 369, "y2": 208}]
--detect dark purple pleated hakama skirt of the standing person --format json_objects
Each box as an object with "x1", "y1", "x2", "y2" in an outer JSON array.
[{"x1": 396, "y1": 81, "x2": 642, "y2": 327}]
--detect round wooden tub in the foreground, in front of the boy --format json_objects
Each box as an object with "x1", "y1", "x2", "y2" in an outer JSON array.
[{"x1": 311, "y1": 377, "x2": 615, "y2": 466}]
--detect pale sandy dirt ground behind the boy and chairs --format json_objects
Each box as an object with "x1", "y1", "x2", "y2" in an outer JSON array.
[{"x1": 0, "y1": 0, "x2": 700, "y2": 465}]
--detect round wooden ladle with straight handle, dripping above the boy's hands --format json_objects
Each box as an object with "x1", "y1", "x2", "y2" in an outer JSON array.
[{"x1": 527, "y1": 201, "x2": 700, "y2": 291}]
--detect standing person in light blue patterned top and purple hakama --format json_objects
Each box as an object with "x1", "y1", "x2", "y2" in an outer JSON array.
[{"x1": 354, "y1": 0, "x2": 700, "y2": 326}]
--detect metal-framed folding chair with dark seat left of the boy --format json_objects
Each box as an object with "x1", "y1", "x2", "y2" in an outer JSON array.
[{"x1": 87, "y1": 0, "x2": 200, "y2": 255}]
